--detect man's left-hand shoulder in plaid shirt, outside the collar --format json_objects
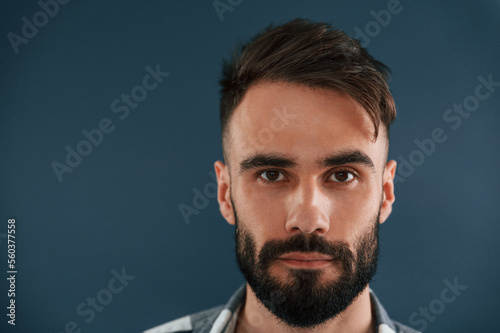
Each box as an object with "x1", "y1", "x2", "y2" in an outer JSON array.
[{"x1": 143, "y1": 305, "x2": 224, "y2": 333}]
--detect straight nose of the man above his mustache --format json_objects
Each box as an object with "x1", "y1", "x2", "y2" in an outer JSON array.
[{"x1": 285, "y1": 180, "x2": 332, "y2": 235}]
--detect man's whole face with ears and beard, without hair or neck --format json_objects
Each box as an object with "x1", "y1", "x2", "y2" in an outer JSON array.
[{"x1": 215, "y1": 83, "x2": 396, "y2": 327}]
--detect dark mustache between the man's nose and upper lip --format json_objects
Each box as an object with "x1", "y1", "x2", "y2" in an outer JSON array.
[{"x1": 259, "y1": 234, "x2": 355, "y2": 269}]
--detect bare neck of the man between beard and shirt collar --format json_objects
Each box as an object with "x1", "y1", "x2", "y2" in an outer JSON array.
[{"x1": 235, "y1": 284, "x2": 377, "y2": 333}]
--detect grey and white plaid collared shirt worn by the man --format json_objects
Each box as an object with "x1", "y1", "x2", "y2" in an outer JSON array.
[{"x1": 144, "y1": 285, "x2": 419, "y2": 333}]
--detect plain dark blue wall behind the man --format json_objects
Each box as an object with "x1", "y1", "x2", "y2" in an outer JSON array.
[{"x1": 0, "y1": 0, "x2": 500, "y2": 333}]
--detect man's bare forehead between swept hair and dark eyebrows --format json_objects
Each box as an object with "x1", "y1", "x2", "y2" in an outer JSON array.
[{"x1": 226, "y1": 82, "x2": 385, "y2": 169}]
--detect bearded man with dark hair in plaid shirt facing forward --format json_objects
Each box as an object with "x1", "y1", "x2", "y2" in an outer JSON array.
[{"x1": 146, "y1": 19, "x2": 415, "y2": 333}]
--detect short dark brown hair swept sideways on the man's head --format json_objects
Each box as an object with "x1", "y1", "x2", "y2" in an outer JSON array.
[{"x1": 219, "y1": 19, "x2": 396, "y2": 145}]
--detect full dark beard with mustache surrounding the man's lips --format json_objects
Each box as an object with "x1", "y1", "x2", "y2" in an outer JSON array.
[{"x1": 233, "y1": 203, "x2": 380, "y2": 328}]
